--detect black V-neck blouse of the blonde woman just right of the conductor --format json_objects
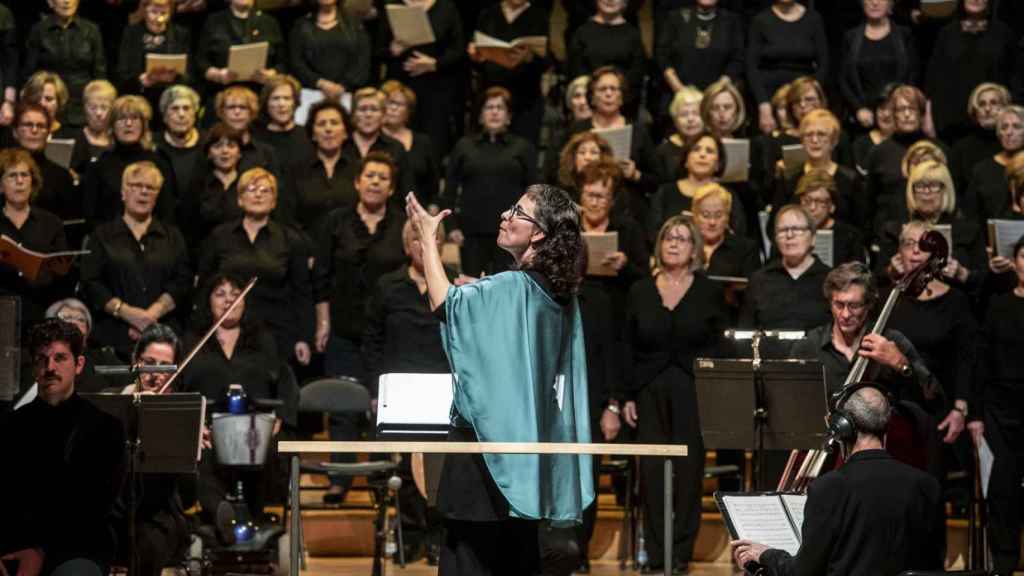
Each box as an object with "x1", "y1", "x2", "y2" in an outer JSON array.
[{"x1": 625, "y1": 274, "x2": 728, "y2": 399}]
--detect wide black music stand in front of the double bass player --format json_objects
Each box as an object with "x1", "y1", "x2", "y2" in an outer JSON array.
[{"x1": 694, "y1": 358, "x2": 828, "y2": 489}]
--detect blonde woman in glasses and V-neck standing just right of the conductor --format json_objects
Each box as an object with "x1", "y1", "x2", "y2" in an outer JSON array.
[{"x1": 623, "y1": 215, "x2": 728, "y2": 573}]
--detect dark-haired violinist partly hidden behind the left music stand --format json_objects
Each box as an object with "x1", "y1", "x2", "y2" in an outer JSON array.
[{"x1": 114, "y1": 324, "x2": 189, "y2": 576}]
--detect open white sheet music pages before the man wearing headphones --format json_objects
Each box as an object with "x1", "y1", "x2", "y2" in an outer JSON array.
[{"x1": 715, "y1": 492, "x2": 807, "y2": 556}]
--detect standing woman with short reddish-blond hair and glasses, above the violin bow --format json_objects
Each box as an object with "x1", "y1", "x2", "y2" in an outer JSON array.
[{"x1": 197, "y1": 168, "x2": 315, "y2": 366}]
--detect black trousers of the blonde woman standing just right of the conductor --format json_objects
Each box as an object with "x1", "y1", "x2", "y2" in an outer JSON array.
[{"x1": 637, "y1": 366, "x2": 705, "y2": 567}]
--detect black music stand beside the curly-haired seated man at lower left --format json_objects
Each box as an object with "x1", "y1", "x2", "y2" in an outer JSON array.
[{"x1": 81, "y1": 393, "x2": 206, "y2": 574}]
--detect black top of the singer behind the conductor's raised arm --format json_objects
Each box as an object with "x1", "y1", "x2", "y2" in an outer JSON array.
[{"x1": 362, "y1": 265, "x2": 456, "y2": 398}]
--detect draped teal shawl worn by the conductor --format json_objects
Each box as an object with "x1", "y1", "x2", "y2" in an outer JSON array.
[{"x1": 441, "y1": 272, "x2": 594, "y2": 523}]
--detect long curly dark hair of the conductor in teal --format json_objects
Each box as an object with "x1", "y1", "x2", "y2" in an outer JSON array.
[{"x1": 523, "y1": 184, "x2": 587, "y2": 300}]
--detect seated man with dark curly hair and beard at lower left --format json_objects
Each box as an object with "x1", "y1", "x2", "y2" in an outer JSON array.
[{"x1": 0, "y1": 319, "x2": 125, "y2": 576}]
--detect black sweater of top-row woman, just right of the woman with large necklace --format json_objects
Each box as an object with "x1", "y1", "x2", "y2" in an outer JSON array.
[{"x1": 746, "y1": 8, "x2": 828, "y2": 104}]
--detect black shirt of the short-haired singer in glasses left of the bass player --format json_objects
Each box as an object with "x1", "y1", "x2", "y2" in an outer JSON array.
[{"x1": 739, "y1": 256, "x2": 829, "y2": 330}]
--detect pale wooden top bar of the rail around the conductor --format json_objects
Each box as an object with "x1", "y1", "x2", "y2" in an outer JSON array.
[{"x1": 278, "y1": 441, "x2": 687, "y2": 457}]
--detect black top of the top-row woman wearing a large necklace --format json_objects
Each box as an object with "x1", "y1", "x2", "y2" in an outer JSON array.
[{"x1": 654, "y1": 7, "x2": 745, "y2": 90}]
